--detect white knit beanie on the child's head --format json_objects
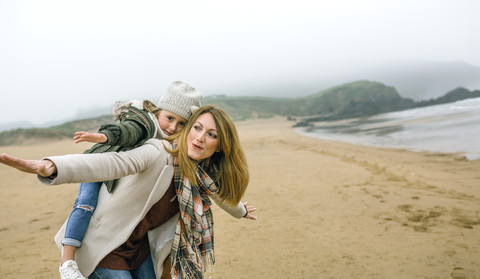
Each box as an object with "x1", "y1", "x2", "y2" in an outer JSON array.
[{"x1": 157, "y1": 81, "x2": 202, "y2": 120}]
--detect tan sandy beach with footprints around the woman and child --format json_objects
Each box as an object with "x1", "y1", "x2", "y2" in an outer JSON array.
[{"x1": 0, "y1": 118, "x2": 480, "y2": 279}]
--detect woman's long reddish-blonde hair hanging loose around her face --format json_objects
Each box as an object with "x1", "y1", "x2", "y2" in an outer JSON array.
[{"x1": 167, "y1": 105, "x2": 249, "y2": 206}]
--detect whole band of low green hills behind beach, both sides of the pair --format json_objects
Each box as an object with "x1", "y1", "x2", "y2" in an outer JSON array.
[{"x1": 0, "y1": 81, "x2": 480, "y2": 145}]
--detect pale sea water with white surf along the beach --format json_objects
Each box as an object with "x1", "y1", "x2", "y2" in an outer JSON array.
[{"x1": 296, "y1": 98, "x2": 480, "y2": 160}]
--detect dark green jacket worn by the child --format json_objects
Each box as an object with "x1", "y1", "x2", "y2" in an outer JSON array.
[{"x1": 83, "y1": 106, "x2": 161, "y2": 193}]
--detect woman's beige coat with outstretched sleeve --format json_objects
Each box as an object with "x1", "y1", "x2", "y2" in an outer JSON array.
[{"x1": 39, "y1": 139, "x2": 246, "y2": 278}]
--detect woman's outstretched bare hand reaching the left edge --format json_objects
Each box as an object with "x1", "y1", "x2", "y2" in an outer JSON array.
[{"x1": 0, "y1": 153, "x2": 57, "y2": 177}]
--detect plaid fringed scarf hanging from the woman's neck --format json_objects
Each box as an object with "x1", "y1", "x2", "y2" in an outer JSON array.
[{"x1": 170, "y1": 153, "x2": 217, "y2": 278}]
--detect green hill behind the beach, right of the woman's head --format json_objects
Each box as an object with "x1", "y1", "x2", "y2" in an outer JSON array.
[{"x1": 203, "y1": 81, "x2": 414, "y2": 119}]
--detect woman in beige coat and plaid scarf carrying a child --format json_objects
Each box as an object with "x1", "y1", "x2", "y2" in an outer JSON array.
[{"x1": 0, "y1": 106, "x2": 256, "y2": 278}]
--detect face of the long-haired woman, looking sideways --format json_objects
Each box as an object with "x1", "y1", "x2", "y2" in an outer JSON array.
[{"x1": 187, "y1": 112, "x2": 219, "y2": 162}]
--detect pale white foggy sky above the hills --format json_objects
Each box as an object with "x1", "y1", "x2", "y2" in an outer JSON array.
[{"x1": 0, "y1": 0, "x2": 480, "y2": 124}]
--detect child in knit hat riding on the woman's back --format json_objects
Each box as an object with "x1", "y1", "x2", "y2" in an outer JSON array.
[{"x1": 59, "y1": 81, "x2": 202, "y2": 279}]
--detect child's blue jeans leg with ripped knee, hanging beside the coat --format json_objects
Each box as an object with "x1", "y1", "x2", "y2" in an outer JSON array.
[{"x1": 62, "y1": 182, "x2": 103, "y2": 247}]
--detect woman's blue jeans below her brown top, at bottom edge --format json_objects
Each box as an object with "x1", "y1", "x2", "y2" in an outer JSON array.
[{"x1": 88, "y1": 254, "x2": 156, "y2": 279}]
